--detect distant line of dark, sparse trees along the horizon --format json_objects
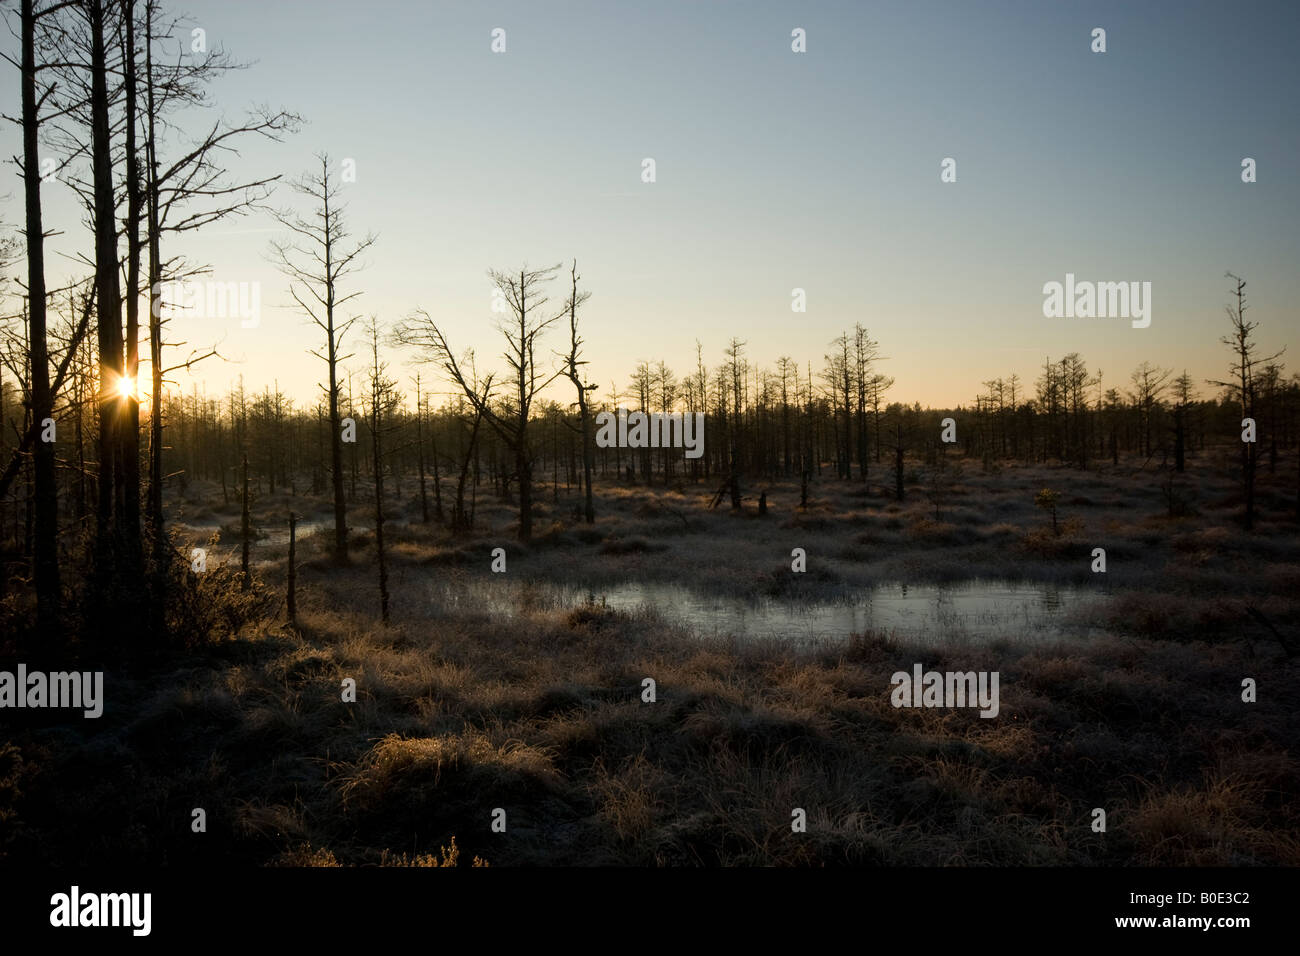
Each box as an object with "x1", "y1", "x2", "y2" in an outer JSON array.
[{"x1": 0, "y1": 334, "x2": 1300, "y2": 555}]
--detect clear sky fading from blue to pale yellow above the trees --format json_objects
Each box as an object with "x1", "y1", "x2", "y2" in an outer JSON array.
[{"x1": 0, "y1": 0, "x2": 1300, "y2": 407}]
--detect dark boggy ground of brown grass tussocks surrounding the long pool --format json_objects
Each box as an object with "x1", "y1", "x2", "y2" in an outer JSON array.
[{"x1": 0, "y1": 449, "x2": 1300, "y2": 865}]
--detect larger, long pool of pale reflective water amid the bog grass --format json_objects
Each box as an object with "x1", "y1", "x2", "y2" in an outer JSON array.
[{"x1": 433, "y1": 579, "x2": 1106, "y2": 643}]
